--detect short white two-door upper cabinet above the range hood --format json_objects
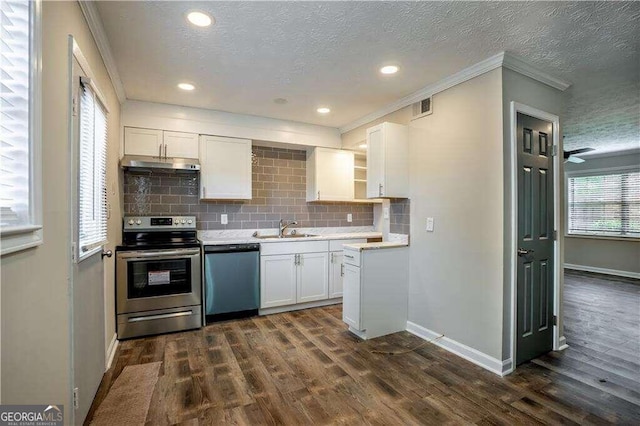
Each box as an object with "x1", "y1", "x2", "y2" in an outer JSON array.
[{"x1": 124, "y1": 127, "x2": 198, "y2": 159}]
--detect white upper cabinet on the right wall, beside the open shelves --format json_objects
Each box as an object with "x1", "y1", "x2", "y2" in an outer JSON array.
[{"x1": 367, "y1": 122, "x2": 409, "y2": 198}]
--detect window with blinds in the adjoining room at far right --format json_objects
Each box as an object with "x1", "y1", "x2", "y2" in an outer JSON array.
[{"x1": 567, "y1": 169, "x2": 640, "y2": 238}]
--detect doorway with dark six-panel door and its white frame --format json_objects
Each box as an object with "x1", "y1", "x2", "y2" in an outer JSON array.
[{"x1": 510, "y1": 102, "x2": 564, "y2": 371}]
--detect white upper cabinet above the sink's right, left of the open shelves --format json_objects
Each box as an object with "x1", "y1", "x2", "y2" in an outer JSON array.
[{"x1": 307, "y1": 147, "x2": 354, "y2": 201}]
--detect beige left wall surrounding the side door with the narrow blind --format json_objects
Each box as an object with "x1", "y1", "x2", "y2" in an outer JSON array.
[{"x1": 1, "y1": 2, "x2": 121, "y2": 412}]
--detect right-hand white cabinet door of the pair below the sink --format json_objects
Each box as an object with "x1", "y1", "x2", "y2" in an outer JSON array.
[{"x1": 298, "y1": 252, "x2": 329, "y2": 303}]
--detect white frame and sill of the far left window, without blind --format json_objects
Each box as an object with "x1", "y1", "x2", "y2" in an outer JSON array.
[{"x1": 0, "y1": 0, "x2": 43, "y2": 255}]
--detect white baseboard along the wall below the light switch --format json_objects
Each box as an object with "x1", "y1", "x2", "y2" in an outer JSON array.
[{"x1": 407, "y1": 321, "x2": 512, "y2": 376}]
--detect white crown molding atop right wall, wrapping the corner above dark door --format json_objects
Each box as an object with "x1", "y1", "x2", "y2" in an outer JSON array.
[{"x1": 340, "y1": 52, "x2": 570, "y2": 134}]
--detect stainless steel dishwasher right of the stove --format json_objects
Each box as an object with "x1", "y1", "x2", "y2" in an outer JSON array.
[{"x1": 204, "y1": 244, "x2": 260, "y2": 323}]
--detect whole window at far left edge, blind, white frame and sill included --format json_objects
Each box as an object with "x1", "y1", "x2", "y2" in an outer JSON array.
[{"x1": 0, "y1": 0, "x2": 42, "y2": 254}]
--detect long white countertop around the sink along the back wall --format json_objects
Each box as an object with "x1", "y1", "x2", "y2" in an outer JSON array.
[{"x1": 198, "y1": 226, "x2": 382, "y2": 246}]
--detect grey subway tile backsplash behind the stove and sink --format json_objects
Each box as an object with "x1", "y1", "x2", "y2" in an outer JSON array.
[{"x1": 124, "y1": 146, "x2": 376, "y2": 233}]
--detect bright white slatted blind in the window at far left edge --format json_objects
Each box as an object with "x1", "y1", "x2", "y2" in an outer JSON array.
[{"x1": 0, "y1": 0, "x2": 31, "y2": 229}]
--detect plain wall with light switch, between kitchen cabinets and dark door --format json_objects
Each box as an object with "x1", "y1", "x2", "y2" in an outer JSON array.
[{"x1": 409, "y1": 69, "x2": 504, "y2": 360}]
